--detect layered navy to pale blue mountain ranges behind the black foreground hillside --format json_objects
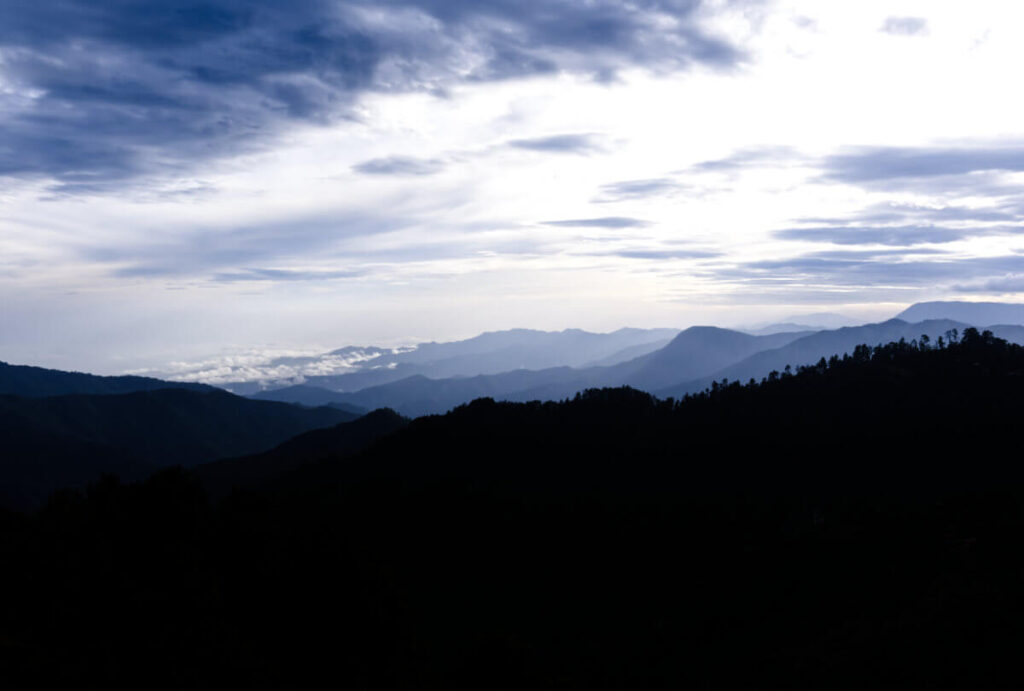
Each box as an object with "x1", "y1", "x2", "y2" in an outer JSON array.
[{"x1": 6, "y1": 303, "x2": 1024, "y2": 506}]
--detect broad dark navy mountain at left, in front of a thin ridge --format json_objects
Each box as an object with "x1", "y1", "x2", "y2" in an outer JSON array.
[{"x1": 0, "y1": 389, "x2": 356, "y2": 507}]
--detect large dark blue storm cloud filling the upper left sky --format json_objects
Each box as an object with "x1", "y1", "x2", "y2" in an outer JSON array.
[{"x1": 0, "y1": 0, "x2": 742, "y2": 186}]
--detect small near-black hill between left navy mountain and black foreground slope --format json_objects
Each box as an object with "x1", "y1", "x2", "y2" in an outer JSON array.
[{"x1": 195, "y1": 408, "x2": 409, "y2": 495}]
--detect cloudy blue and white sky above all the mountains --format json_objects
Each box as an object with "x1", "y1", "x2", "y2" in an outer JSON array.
[{"x1": 0, "y1": 0, "x2": 1024, "y2": 374}]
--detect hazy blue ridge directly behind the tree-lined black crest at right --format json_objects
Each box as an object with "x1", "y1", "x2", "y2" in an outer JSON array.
[{"x1": 653, "y1": 319, "x2": 967, "y2": 397}]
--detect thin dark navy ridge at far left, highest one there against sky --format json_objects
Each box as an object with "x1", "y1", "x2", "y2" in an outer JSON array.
[{"x1": 0, "y1": 362, "x2": 215, "y2": 397}]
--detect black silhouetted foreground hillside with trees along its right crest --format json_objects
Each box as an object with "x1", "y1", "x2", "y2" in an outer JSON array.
[{"x1": 6, "y1": 331, "x2": 1024, "y2": 689}]
